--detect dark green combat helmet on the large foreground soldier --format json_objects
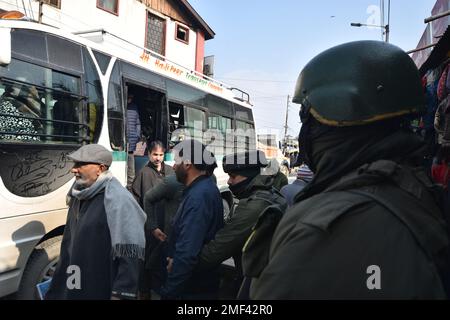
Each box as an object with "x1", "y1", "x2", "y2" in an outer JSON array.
[{"x1": 293, "y1": 41, "x2": 425, "y2": 127}]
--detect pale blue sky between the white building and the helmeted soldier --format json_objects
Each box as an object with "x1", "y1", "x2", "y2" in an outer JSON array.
[{"x1": 189, "y1": 0, "x2": 436, "y2": 139}]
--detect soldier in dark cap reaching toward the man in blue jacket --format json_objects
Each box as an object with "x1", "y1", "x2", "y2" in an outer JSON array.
[{"x1": 198, "y1": 150, "x2": 287, "y2": 298}]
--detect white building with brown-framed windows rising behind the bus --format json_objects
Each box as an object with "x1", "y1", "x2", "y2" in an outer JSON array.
[{"x1": 0, "y1": 0, "x2": 215, "y2": 73}]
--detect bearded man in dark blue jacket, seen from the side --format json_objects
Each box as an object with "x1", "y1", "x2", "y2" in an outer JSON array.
[{"x1": 161, "y1": 140, "x2": 223, "y2": 299}]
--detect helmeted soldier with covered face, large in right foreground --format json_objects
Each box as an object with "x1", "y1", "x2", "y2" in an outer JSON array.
[{"x1": 250, "y1": 41, "x2": 449, "y2": 299}]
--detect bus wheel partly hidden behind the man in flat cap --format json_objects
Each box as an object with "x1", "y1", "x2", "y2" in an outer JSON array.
[{"x1": 17, "y1": 236, "x2": 62, "y2": 300}]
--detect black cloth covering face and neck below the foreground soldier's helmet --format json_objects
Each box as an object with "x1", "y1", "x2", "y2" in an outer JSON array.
[{"x1": 296, "y1": 116, "x2": 425, "y2": 201}]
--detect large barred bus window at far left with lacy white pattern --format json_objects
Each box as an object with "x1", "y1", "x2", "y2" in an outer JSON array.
[{"x1": 0, "y1": 59, "x2": 86, "y2": 144}]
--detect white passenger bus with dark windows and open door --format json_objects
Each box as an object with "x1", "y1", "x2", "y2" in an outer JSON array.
[{"x1": 0, "y1": 20, "x2": 256, "y2": 299}]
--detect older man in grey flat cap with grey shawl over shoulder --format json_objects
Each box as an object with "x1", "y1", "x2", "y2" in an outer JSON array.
[{"x1": 45, "y1": 144, "x2": 145, "y2": 300}]
